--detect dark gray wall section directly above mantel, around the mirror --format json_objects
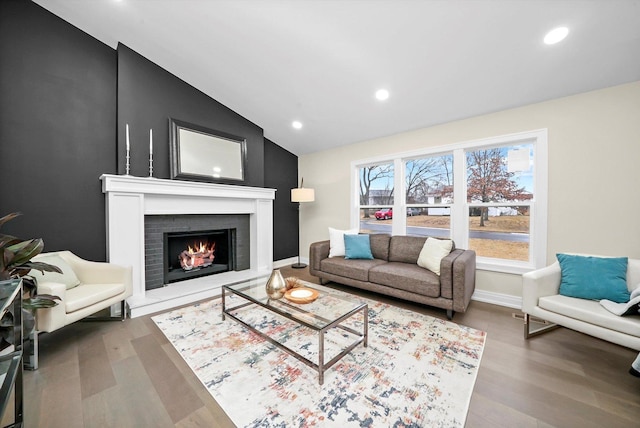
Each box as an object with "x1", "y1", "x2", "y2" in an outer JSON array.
[{"x1": 118, "y1": 44, "x2": 264, "y2": 187}]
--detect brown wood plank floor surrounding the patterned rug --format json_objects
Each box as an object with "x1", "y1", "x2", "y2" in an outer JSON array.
[{"x1": 25, "y1": 268, "x2": 640, "y2": 428}]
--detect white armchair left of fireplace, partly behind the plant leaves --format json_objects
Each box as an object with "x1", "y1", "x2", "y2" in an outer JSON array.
[{"x1": 31, "y1": 251, "x2": 133, "y2": 332}]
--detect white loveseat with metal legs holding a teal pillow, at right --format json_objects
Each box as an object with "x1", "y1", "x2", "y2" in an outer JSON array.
[{"x1": 522, "y1": 256, "x2": 640, "y2": 351}]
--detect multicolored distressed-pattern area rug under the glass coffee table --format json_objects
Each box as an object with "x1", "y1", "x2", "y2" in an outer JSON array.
[{"x1": 153, "y1": 285, "x2": 485, "y2": 428}]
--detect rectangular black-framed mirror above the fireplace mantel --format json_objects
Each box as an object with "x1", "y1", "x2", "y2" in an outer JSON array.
[{"x1": 169, "y1": 119, "x2": 247, "y2": 181}]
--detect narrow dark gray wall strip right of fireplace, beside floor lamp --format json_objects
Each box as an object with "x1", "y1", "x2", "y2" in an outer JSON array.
[{"x1": 264, "y1": 138, "x2": 299, "y2": 260}]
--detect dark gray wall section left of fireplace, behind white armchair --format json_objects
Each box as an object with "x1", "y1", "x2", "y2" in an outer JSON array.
[{"x1": 0, "y1": 0, "x2": 117, "y2": 260}]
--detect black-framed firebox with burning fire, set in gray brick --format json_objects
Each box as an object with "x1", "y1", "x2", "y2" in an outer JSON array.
[{"x1": 163, "y1": 229, "x2": 235, "y2": 284}]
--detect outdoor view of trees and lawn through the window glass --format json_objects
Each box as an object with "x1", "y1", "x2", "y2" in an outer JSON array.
[{"x1": 358, "y1": 143, "x2": 535, "y2": 261}]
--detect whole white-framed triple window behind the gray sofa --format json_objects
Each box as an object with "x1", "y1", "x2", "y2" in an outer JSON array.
[{"x1": 352, "y1": 130, "x2": 547, "y2": 273}]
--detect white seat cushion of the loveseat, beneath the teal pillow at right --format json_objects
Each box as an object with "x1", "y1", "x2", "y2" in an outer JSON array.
[{"x1": 538, "y1": 294, "x2": 640, "y2": 337}]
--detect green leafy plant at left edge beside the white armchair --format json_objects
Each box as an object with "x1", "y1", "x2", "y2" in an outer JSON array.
[{"x1": 0, "y1": 213, "x2": 62, "y2": 350}]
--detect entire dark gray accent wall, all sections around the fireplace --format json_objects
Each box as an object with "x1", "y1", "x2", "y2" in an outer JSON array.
[{"x1": 0, "y1": 0, "x2": 298, "y2": 261}]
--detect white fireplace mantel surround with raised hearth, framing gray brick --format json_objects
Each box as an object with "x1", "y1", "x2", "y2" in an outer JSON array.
[{"x1": 100, "y1": 174, "x2": 275, "y2": 317}]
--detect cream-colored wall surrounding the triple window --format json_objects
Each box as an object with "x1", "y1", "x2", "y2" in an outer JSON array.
[{"x1": 299, "y1": 81, "x2": 640, "y2": 296}]
